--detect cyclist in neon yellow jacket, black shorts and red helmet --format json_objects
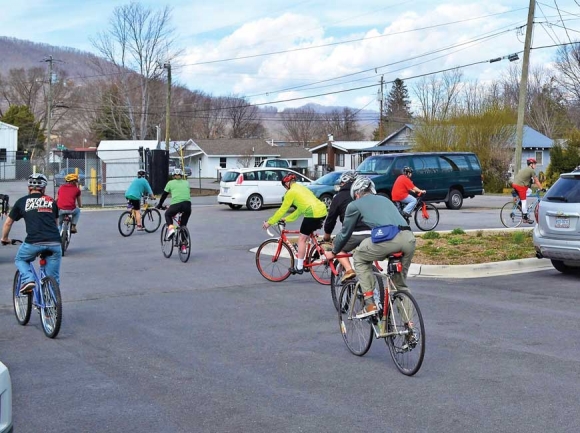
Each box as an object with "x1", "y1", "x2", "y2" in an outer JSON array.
[{"x1": 262, "y1": 173, "x2": 327, "y2": 274}]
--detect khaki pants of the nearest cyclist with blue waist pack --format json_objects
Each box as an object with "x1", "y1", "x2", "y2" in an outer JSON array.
[{"x1": 353, "y1": 230, "x2": 415, "y2": 293}]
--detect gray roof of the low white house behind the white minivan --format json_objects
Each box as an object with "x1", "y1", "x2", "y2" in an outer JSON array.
[{"x1": 193, "y1": 138, "x2": 312, "y2": 159}]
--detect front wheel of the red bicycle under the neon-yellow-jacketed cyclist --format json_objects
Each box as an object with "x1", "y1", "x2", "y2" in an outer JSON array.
[{"x1": 256, "y1": 239, "x2": 294, "y2": 282}]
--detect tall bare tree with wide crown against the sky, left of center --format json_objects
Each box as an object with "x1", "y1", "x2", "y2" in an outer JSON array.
[{"x1": 92, "y1": 2, "x2": 178, "y2": 140}]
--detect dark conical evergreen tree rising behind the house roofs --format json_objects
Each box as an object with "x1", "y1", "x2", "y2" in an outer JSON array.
[{"x1": 373, "y1": 78, "x2": 413, "y2": 140}]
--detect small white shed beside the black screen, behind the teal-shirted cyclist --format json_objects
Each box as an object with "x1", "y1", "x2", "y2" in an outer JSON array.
[{"x1": 97, "y1": 140, "x2": 165, "y2": 192}]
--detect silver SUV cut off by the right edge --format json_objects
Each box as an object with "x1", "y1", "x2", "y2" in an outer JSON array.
[{"x1": 533, "y1": 169, "x2": 580, "y2": 273}]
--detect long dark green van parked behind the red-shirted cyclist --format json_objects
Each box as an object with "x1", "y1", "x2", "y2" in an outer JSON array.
[{"x1": 356, "y1": 152, "x2": 483, "y2": 209}]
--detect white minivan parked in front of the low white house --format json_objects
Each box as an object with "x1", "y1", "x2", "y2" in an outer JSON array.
[{"x1": 217, "y1": 167, "x2": 312, "y2": 210}]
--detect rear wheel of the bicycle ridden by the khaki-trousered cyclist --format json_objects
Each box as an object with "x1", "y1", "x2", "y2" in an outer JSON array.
[{"x1": 385, "y1": 290, "x2": 425, "y2": 376}]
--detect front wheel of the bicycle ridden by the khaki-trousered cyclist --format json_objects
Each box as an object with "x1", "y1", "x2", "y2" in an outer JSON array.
[{"x1": 338, "y1": 281, "x2": 373, "y2": 356}]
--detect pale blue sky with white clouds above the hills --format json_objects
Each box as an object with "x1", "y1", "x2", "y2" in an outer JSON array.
[{"x1": 0, "y1": 0, "x2": 580, "y2": 117}]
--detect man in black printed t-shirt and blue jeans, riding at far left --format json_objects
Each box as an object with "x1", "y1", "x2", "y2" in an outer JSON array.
[{"x1": 1, "y1": 173, "x2": 62, "y2": 293}]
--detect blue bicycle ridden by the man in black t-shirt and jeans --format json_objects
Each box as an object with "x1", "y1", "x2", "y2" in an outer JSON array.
[{"x1": 12, "y1": 240, "x2": 62, "y2": 338}]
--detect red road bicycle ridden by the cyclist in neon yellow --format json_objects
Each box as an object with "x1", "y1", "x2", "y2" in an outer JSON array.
[{"x1": 256, "y1": 221, "x2": 332, "y2": 286}]
